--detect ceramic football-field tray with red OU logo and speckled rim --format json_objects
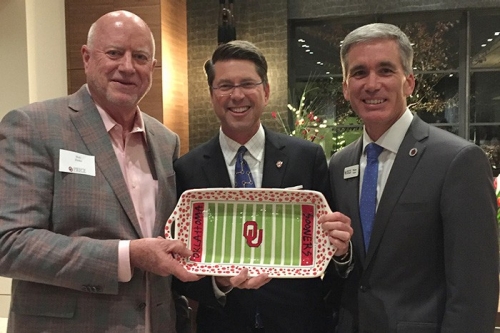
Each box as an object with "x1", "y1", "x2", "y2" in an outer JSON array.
[{"x1": 165, "y1": 188, "x2": 335, "y2": 278}]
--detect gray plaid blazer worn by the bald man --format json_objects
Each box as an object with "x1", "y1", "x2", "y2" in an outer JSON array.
[{"x1": 0, "y1": 87, "x2": 179, "y2": 333}]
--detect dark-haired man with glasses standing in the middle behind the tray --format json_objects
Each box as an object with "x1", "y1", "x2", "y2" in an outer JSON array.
[{"x1": 174, "y1": 41, "x2": 352, "y2": 333}]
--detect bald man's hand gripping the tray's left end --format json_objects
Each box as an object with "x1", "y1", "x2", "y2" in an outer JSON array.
[{"x1": 130, "y1": 237, "x2": 201, "y2": 282}]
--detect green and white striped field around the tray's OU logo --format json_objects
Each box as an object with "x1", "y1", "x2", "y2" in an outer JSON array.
[{"x1": 202, "y1": 202, "x2": 302, "y2": 266}]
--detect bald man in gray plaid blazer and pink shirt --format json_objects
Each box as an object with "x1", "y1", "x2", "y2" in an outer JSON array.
[{"x1": 0, "y1": 11, "x2": 198, "y2": 333}]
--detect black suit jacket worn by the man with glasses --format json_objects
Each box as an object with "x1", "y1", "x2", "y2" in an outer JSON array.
[{"x1": 174, "y1": 130, "x2": 330, "y2": 333}]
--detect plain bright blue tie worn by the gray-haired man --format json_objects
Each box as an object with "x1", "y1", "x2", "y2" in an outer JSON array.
[{"x1": 359, "y1": 142, "x2": 384, "y2": 252}]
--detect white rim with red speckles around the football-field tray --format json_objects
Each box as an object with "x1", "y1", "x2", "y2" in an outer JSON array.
[{"x1": 165, "y1": 188, "x2": 335, "y2": 278}]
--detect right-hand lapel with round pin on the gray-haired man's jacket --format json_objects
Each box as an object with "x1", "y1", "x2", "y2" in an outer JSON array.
[{"x1": 365, "y1": 116, "x2": 429, "y2": 268}]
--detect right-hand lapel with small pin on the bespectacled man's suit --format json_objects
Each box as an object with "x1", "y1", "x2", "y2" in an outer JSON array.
[{"x1": 262, "y1": 128, "x2": 289, "y2": 188}]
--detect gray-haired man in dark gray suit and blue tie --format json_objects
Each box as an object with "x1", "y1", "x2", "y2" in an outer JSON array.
[{"x1": 329, "y1": 23, "x2": 498, "y2": 333}]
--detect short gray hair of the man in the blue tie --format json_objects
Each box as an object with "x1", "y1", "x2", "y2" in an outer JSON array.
[{"x1": 340, "y1": 23, "x2": 413, "y2": 80}]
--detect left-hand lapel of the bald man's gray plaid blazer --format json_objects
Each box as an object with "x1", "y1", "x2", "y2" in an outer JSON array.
[{"x1": 69, "y1": 86, "x2": 142, "y2": 237}]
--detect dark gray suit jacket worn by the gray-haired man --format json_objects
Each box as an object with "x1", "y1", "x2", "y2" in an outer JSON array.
[{"x1": 329, "y1": 116, "x2": 498, "y2": 333}]
